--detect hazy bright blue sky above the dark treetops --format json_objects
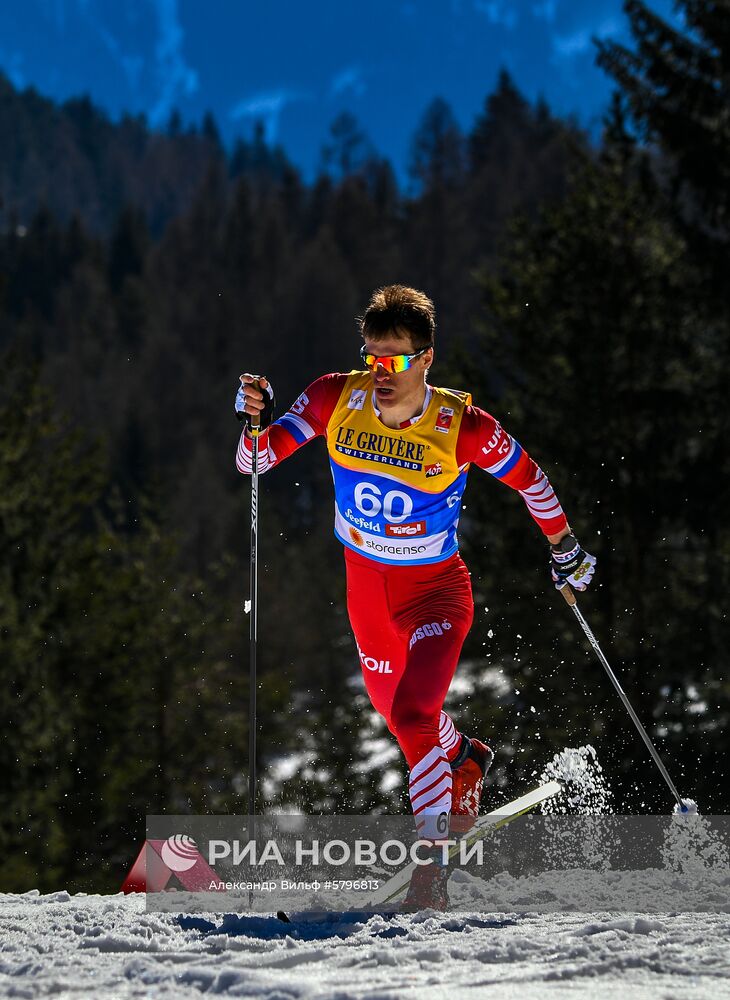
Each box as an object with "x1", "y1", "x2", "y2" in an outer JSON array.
[{"x1": 0, "y1": 0, "x2": 676, "y2": 177}]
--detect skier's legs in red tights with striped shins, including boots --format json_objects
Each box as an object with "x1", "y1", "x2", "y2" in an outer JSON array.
[{"x1": 346, "y1": 551, "x2": 492, "y2": 908}]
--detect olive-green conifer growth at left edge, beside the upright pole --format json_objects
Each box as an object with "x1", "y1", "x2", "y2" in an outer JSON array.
[{"x1": 0, "y1": 354, "x2": 245, "y2": 891}]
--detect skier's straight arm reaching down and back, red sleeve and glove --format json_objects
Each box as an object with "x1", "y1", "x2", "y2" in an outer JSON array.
[{"x1": 456, "y1": 406, "x2": 596, "y2": 590}]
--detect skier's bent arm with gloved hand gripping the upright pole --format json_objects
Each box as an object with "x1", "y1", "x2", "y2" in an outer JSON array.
[{"x1": 236, "y1": 373, "x2": 347, "y2": 475}]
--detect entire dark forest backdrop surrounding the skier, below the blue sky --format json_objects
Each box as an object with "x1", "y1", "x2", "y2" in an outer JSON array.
[{"x1": 0, "y1": 0, "x2": 730, "y2": 891}]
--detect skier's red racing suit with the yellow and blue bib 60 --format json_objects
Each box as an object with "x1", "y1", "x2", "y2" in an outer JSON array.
[{"x1": 236, "y1": 372, "x2": 567, "y2": 835}]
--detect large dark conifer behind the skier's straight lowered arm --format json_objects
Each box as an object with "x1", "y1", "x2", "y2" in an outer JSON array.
[{"x1": 465, "y1": 104, "x2": 728, "y2": 807}]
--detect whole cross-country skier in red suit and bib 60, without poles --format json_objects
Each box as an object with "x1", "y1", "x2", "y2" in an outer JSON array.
[{"x1": 236, "y1": 285, "x2": 595, "y2": 908}]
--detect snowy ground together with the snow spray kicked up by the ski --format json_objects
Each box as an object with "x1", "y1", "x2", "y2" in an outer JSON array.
[{"x1": 0, "y1": 746, "x2": 730, "y2": 1000}]
